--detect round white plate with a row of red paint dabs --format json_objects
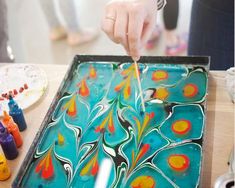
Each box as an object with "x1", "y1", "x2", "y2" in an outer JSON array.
[{"x1": 0, "y1": 64, "x2": 48, "y2": 116}]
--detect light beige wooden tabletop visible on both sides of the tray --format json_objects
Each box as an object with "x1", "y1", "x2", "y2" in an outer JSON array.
[{"x1": 0, "y1": 64, "x2": 234, "y2": 188}]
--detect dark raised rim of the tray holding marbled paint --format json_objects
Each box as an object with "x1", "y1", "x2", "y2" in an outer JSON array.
[{"x1": 12, "y1": 55, "x2": 210, "y2": 188}]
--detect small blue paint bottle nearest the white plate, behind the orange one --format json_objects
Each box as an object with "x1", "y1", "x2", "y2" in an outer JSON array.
[{"x1": 8, "y1": 96, "x2": 27, "y2": 131}]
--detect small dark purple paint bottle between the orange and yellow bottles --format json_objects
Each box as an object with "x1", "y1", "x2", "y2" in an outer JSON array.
[{"x1": 0, "y1": 122, "x2": 18, "y2": 160}]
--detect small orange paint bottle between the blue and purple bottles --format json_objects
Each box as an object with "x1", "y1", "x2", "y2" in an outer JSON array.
[{"x1": 2, "y1": 111, "x2": 23, "y2": 148}]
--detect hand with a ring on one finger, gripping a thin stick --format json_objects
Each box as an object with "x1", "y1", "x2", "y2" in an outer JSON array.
[{"x1": 102, "y1": 0, "x2": 157, "y2": 61}]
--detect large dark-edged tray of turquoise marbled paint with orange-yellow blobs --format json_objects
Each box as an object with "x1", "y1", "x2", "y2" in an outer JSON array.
[{"x1": 12, "y1": 56, "x2": 209, "y2": 188}]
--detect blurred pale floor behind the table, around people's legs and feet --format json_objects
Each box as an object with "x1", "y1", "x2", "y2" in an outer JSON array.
[{"x1": 6, "y1": 0, "x2": 192, "y2": 64}]
